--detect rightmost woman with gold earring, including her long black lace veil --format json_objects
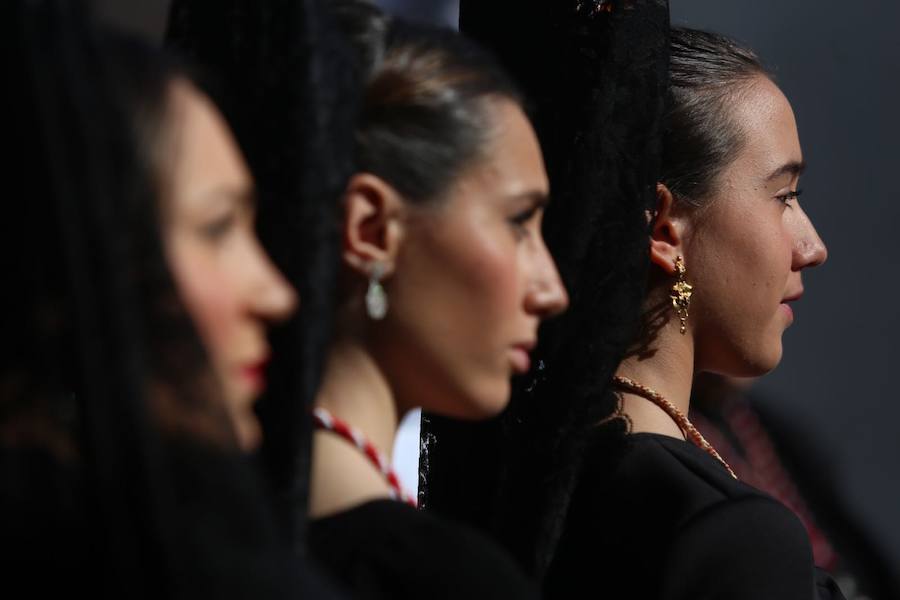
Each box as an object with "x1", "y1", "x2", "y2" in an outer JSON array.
[{"x1": 424, "y1": 2, "x2": 840, "y2": 598}]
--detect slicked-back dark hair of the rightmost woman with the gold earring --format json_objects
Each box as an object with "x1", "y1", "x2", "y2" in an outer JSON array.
[{"x1": 660, "y1": 27, "x2": 770, "y2": 207}]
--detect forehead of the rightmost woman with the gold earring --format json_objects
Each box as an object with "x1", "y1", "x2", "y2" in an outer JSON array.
[{"x1": 732, "y1": 77, "x2": 803, "y2": 176}]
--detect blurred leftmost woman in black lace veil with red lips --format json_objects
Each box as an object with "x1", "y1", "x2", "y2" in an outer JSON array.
[{"x1": 0, "y1": 0, "x2": 342, "y2": 598}]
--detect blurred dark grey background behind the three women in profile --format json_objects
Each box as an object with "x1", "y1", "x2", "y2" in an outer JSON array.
[{"x1": 98, "y1": 0, "x2": 900, "y2": 592}]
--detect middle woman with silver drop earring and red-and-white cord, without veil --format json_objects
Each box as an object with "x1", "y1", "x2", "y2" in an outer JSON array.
[{"x1": 309, "y1": 3, "x2": 567, "y2": 598}]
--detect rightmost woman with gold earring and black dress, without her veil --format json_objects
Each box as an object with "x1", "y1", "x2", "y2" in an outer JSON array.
[{"x1": 545, "y1": 28, "x2": 842, "y2": 600}]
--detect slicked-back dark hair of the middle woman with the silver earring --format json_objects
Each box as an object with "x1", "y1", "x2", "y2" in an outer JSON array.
[{"x1": 338, "y1": 2, "x2": 522, "y2": 202}]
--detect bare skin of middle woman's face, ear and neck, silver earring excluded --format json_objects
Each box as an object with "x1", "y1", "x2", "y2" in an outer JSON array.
[{"x1": 310, "y1": 100, "x2": 568, "y2": 516}]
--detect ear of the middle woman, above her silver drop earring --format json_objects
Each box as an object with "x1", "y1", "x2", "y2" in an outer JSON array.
[{"x1": 341, "y1": 173, "x2": 405, "y2": 276}]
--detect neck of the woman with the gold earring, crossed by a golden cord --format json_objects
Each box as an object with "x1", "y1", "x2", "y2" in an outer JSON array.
[{"x1": 616, "y1": 319, "x2": 694, "y2": 439}]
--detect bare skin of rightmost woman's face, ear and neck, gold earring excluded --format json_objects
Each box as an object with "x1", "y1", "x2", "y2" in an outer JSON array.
[{"x1": 619, "y1": 76, "x2": 827, "y2": 437}]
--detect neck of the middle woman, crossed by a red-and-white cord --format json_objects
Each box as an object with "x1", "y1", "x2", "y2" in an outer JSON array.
[{"x1": 309, "y1": 338, "x2": 400, "y2": 518}]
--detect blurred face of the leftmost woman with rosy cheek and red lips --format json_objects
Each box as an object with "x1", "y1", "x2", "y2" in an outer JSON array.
[{"x1": 164, "y1": 81, "x2": 297, "y2": 449}]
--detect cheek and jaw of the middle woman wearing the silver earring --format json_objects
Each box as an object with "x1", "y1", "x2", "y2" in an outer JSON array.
[{"x1": 378, "y1": 216, "x2": 520, "y2": 418}]
